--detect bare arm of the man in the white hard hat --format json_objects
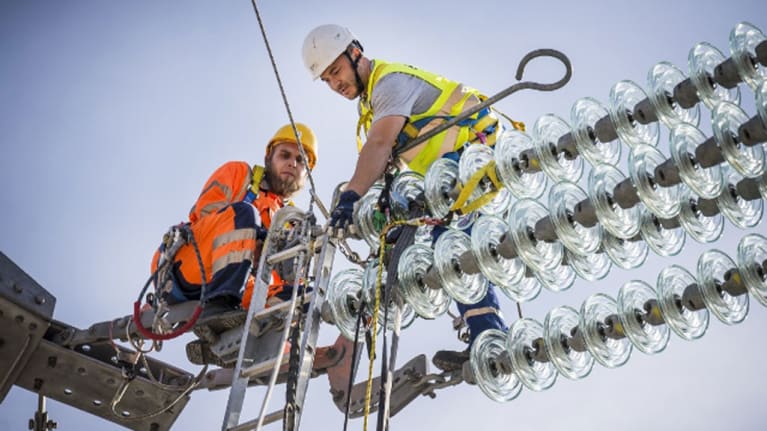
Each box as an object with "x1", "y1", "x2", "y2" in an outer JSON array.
[{"x1": 346, "y1": 115, "x2": 406, "y2": 196}]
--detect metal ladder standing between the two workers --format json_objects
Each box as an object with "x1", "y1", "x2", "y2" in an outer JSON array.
[{"x1": 222, "y1": 207, "x2": 336, "y2": 431}]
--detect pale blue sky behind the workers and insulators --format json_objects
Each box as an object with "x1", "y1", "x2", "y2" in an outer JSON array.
[{"x1": 0, "y1": 0, "x2": 767, "y2": 431}]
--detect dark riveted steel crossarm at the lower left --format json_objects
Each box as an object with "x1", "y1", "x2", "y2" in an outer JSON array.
[{"x1": 0, "y1": 252, "x2": 196, "y2": 431}]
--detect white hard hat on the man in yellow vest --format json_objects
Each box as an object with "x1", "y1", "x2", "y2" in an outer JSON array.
[{"x1": 302, "y1": 24, "x2": 356, "y2": 79}]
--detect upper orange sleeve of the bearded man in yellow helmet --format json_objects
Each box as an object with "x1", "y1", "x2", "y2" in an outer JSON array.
[{"x1": 189, "y1": 162, "x2": 251, "y2": 223}]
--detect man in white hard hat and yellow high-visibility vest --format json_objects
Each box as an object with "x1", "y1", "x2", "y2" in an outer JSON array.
[{"x1": 302, "y1": 24, "x2": 521, "y2": 370}]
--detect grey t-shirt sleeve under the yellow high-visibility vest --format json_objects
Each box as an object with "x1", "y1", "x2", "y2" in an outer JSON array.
[{"x1": 358, "y1": 62, "x2": 440, "y2": 123}]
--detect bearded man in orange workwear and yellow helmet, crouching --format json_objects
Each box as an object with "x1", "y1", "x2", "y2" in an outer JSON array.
[{"x1": 152, "y1": 123, "x2": 317, "y2": 363}]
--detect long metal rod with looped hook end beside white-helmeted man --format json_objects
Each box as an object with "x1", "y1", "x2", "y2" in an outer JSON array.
[{"x1": 394, "y1": 49, "x2": 573, "y2": 156}]
